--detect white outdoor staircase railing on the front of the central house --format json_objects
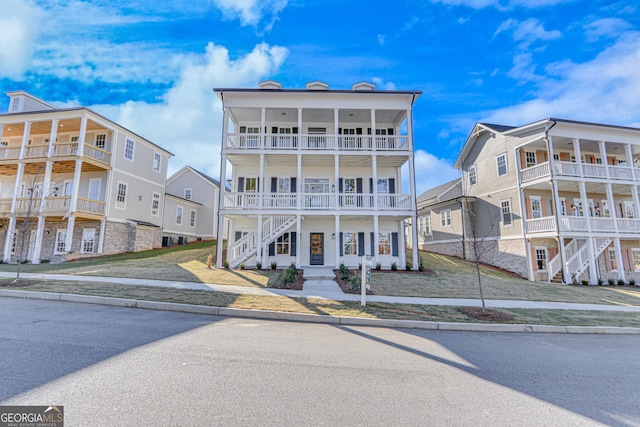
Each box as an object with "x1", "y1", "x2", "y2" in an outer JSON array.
[{"x1": 227, "y1": 216, "x2": 296, "y2": 267}]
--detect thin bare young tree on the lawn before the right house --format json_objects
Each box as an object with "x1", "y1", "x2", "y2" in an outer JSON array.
[{"x1": 462, "y1": 199, "x2": 500, "y2": 312}]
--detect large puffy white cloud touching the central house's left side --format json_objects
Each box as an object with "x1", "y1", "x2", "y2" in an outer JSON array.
[{"x1": 93, "y1": 43, "x2": 288, "y2": 177}]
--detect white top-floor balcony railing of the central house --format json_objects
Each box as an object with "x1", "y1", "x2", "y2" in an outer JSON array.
[{"x1": 225, "y1": 133, "x2": 411, "y2": 151}]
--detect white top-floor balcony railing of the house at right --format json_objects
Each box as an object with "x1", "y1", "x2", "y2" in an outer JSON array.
[{"x1": 520, "y1": 160, "x2": 640, "y2": 184}]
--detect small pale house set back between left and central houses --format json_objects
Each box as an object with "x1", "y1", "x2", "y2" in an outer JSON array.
[{"x1": 162, "y1": 166, "x2": 225, "y2": 246}]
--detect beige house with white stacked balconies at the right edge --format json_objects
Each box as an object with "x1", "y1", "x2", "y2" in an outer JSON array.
[{"x1": 418, "y1": 118, "x2": 640, "y2": 284}]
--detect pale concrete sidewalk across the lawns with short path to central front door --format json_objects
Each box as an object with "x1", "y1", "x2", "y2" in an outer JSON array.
[{"x1": 0, "y1": 268, "x2": 640, "y2": 313}]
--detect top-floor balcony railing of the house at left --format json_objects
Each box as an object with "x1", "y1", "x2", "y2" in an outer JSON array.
[{"x1": 0, "y1": 142, "x2": 111, "y2": 166}]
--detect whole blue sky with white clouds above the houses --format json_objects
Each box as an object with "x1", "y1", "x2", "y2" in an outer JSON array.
[{"x1": 0, "y1": 0, "x2": 640, "y2": 192}]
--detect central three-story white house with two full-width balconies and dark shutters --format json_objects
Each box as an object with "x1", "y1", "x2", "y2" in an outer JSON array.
[{"x1": 214, "y1": 81, "x2": 421, "y2": 268}]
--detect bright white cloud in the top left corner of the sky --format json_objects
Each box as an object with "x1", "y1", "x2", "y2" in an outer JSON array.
[{"x1": 0, "y1": 0, "x2": 41, "y2": 80}]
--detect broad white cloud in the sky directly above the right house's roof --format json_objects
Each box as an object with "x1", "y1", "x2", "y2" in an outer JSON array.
[{"x1": 481, "y1": 32, "x2": 640, "y2": 125}]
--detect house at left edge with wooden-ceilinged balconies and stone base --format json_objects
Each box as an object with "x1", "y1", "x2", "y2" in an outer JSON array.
[{"x1": 0, "y1": 91, "x2": 172, "y2": 263}]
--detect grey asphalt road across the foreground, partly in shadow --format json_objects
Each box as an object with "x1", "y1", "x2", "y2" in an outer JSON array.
[{"x1": 0, "y1": 298, "x2": 640, "y2": 426}]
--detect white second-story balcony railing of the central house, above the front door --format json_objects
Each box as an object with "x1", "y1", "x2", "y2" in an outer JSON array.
[{"x1": 224, "y1": 192, "x2": 415, "y2": 211}]
